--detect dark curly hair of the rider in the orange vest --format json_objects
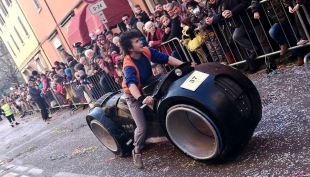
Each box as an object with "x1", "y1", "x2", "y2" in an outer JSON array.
[{"x1": 119, "y1": 30, "x2": 140, "y2": 55}]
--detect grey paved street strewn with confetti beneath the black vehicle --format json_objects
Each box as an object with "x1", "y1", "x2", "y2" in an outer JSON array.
[{"x1": 0, "y1": 67, "x2": 310, "y2": 177}]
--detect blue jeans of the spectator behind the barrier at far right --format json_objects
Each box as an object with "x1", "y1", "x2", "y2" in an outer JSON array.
[{"x1": 269, "y1": 23, "x2": 303, "y2": 57}]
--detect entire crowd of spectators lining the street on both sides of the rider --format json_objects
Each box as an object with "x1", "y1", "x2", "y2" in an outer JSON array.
[{"x1": 1, "y1": 0, "x2": 310, "y2": 122}]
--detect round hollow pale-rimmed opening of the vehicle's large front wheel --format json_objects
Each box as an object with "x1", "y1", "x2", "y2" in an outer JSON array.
[{"x1": 166, "y1": 104, "x2": 223, "y2": 161}]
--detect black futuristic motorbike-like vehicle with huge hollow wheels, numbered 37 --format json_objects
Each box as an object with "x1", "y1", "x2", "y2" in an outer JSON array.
[{"x1": 86, "y1": 63, "x2": 262, "y2": 161}]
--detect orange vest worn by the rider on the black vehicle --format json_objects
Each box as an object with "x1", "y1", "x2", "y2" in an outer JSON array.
[{"x1": 122, "y1": 47, "x2": 151, "y2": 94}]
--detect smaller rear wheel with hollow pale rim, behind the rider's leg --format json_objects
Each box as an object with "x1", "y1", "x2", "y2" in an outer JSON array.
[{"x1": 90, "y1": 119, "x2": 133, "y2": 157}]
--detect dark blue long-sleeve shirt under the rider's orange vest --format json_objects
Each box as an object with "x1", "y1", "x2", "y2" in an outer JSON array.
[{"x1": 124, "y1": 48, "x2": 169, "y2": 88}]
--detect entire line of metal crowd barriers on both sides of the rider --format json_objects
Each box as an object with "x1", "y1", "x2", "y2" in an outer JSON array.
[{"x1": 23, "y1": 0, "x2": 310, "y2": 115}]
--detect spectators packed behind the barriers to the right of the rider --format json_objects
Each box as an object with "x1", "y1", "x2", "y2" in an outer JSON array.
[{"x1": 118, "y1": 0, "x2": 310, "y2": 73}]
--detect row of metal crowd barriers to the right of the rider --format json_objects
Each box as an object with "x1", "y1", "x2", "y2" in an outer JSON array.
[{"x1": 155, "y1": 0, "x2": 310, "y2": 66}]
